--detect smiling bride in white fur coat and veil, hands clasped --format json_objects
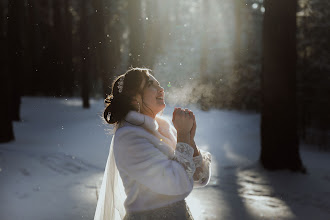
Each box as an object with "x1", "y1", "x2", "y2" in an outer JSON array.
[{"x1": 94, "y1": 68, "x2": 211, "y2": 220}]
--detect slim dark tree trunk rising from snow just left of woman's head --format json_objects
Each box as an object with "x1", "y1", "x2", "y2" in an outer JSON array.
[{"x1": 80, "y1": 0, "x2": 90, "y2": 108}]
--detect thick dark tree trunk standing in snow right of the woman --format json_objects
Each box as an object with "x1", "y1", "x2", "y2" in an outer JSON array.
[{"x1": 260, "y1": 0, "x2": 305, "y2": 171}]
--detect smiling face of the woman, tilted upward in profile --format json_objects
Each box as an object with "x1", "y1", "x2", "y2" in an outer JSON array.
[{"x1": 138, "y1": 75, "x2": 166, "y2": 118}]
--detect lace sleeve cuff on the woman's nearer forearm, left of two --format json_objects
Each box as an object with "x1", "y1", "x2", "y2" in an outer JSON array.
[{"x1": 173, "y1": 142, "x2": 196, "y2": 179}]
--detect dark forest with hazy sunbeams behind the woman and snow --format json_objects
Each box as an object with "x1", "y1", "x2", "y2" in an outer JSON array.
[{"x1": 0, "y1": 0, "x2": 330, "y2": 165}]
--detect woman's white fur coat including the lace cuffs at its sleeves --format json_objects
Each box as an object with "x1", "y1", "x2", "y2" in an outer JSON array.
[{"x1": 113, "y1": 111, "x2": 211, "y2": 211}]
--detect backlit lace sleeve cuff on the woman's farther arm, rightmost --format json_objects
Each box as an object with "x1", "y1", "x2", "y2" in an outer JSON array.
[{"x1": 193, "y1": 149, "x2": 212, "y2": 184}]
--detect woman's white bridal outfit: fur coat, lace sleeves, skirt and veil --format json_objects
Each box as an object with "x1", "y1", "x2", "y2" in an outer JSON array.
[{"x1": 94, "y1": 111, "x2": 211, "y2": 220}]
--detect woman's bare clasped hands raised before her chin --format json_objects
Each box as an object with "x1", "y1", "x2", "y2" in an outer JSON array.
[{"x1": 172, "y1": 108, "x2": 194, "y2": 144}]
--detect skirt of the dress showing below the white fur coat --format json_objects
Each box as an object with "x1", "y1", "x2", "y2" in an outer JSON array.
[{"x1": 123, "y1": 200, "x2": 194, "y2": 220}]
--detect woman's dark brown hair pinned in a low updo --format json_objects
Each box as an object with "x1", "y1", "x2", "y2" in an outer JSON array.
[{"x1": 103, "y1": 68, "x2": 151, "y2": 124}]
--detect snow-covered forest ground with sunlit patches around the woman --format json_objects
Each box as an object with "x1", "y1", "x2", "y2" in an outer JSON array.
[{"x1": 0, "y1": 97, "x2": 330, "y2": 220}]
